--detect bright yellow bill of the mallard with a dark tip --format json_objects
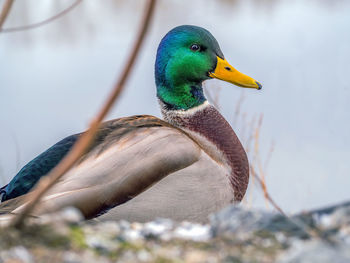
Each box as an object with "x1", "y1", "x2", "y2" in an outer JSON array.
[{"x1": 209, "y1": 57, "x2": 262, "y2": 89}]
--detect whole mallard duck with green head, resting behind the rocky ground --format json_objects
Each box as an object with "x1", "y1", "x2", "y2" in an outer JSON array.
[{"x1": 0, "y1": 25, "x2": 262, "y2": 222}]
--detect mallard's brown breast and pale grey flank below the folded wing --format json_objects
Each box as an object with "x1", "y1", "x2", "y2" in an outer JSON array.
[{"x1": 102, "y1": 103, "x2": 248, "y2": 222}]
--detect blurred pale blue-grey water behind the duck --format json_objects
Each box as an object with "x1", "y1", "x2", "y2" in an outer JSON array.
[{"x1": 0, "y1": 0, "x2": 350, "y2": 213}]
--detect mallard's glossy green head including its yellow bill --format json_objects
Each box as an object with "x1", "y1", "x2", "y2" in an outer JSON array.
[{"x1": 155, "y1": 25, "x2": 261, "y2": 110}]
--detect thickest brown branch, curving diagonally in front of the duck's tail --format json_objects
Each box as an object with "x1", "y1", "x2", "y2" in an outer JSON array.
[{"x1": 11, "y1": 0, "x2": 156, "y2": 228}]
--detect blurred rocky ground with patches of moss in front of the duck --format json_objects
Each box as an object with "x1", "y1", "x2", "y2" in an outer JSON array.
[{"x1": 0, "y1": 202, "x2": 350, "y2": 263}]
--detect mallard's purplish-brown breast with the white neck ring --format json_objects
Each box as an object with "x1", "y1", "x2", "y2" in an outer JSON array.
[{"x1": 160, "y1": 100, "x2": 249, "y2": 201}]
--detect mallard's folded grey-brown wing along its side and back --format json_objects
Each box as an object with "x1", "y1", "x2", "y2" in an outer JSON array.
[{"x1": 0, "y1": 116, "x2": 201, "y2": 218}]
